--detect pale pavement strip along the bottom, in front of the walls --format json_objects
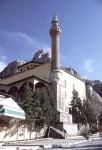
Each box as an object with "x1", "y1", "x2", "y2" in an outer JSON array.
[{"x1": 0, "y1": 134, "x2": 101, "y2": 150}]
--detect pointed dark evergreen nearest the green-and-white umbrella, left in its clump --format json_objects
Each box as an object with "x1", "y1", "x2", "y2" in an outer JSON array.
[{"x1": 20, "y1": 82, "x2": 42, "y2": 123}]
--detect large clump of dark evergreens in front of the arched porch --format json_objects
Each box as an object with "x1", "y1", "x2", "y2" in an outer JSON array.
[{"x1": 20, "y1": 83, "x2": 57, "y2": 127}]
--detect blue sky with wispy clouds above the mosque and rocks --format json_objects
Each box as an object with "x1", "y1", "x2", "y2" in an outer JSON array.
[{"x1": 0, "y1": 0, "x2": 102, "y2": 80}]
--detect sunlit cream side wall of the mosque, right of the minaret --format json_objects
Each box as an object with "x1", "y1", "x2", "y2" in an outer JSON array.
[{"x1": 57, "y1": 70, "x2": 86, "y2": 113}]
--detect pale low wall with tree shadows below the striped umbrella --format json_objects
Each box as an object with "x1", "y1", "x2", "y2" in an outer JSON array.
[{"x1": 0, "y1": 119, "x2": 46, "y2": 142}]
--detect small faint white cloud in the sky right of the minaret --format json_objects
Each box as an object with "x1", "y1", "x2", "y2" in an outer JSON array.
[{"x1": 84, "y1": 59, "x2": 95, "y2": 73}]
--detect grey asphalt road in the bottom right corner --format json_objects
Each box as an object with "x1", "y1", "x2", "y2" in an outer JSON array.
[{"x1": 46, "y1": 140, "x2": 102, "y2": 150}]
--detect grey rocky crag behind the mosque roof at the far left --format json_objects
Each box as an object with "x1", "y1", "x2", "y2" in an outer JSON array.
[{"x1": 0, "y1": 60, "x2": 27, "y2": 79}]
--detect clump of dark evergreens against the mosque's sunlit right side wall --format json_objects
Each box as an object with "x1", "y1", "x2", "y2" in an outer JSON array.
[{"x1": 71, "y1": 90, "x2": 98, "y2": 130}]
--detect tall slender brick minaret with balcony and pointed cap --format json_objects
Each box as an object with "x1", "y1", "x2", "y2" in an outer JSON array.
[{"x1": 49, "y1": 15, "x2": 61, "y2": 71}]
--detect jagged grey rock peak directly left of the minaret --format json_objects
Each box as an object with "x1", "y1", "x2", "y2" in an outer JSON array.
[{"x1": 32, "y1": 49, "x2": 50, "y2": 63}]
